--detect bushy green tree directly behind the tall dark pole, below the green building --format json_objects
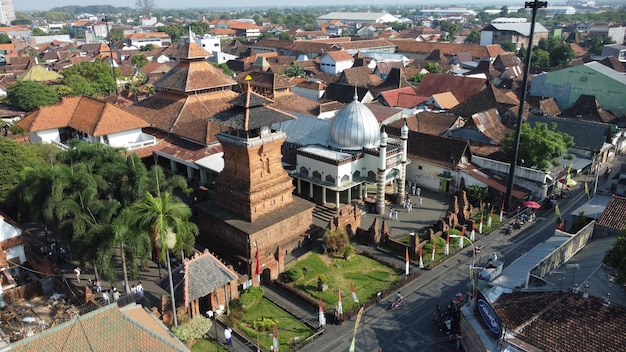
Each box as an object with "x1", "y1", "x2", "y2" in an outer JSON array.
[{"x1": 501, "y1": 122, "x2": 574, "y2": 170}]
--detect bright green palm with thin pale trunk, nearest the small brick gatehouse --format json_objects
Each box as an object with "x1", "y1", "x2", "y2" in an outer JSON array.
[{"x1": 128, "y1": 188, "x2": 198, "y2": 326}]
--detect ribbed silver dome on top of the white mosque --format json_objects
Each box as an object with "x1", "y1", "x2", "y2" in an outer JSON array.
[{"x1": 330, "y1": 99, "x2": 380, "y2": 150}]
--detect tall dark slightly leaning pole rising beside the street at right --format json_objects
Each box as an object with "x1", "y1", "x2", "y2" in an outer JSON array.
[{"x1": 505, "y1": 0, "x2": 548, "y2": 209}]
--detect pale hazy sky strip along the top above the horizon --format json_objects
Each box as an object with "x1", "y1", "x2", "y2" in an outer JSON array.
[{"x1": 13, "y1": 0, "x2": 524, "y2": 11}]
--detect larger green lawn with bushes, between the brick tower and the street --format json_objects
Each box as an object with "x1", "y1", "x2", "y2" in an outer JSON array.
[{"x1": 285, "y1": 252, "x2": 404, "y2": 312}]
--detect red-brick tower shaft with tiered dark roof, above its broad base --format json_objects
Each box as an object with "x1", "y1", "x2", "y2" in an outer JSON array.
[{"x1": 209, "y1": 89, "x2": 294, "y2": 222}]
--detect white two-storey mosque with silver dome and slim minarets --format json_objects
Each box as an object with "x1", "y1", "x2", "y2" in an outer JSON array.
[{"x1": 276, "y1": 95, "x2": 409, "y2": 214}]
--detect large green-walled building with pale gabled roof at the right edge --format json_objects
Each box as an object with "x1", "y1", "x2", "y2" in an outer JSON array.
[{"x1": 529, "y1": 61, "x2": 626, "y2": 114}]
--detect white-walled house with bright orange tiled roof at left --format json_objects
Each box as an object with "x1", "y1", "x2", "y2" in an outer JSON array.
[{"x1": 17, "y1": 97, "x2": 156, "y2": 150}]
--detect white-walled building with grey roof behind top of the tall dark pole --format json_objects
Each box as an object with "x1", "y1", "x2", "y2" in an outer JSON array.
[{"x1": 480, "y1": 22, "x2": 550, "y2": 49}]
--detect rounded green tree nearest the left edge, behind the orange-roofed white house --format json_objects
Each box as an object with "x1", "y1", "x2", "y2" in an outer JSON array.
[{"x1": 7, "y1": 81, "x2": 59, "y2": 111}]
